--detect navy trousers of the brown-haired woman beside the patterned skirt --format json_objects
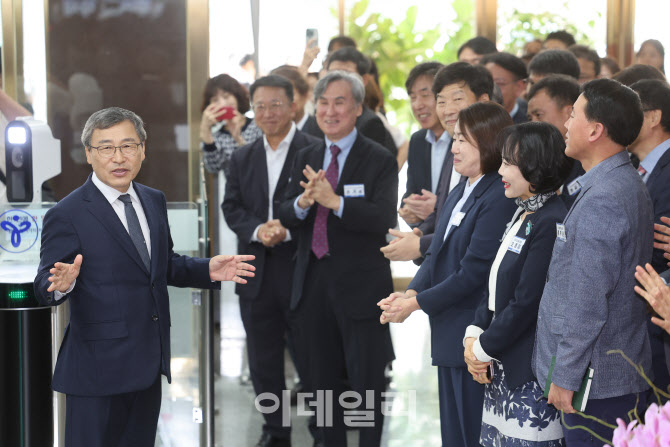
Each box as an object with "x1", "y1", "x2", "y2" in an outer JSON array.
[{"x1": 437, "y1": 366, "x2": 484, "y2": 447}]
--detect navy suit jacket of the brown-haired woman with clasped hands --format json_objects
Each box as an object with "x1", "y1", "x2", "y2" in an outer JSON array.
[{"x1": 409, "y1": 172, "x2": 516, "y2": 367}]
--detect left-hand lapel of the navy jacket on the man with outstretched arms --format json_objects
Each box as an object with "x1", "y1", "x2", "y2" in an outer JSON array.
[{"x1": 84, "y1": 176, "x2": 154, "y2": 274}]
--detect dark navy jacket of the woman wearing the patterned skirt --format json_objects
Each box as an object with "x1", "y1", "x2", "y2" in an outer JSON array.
[{"x1": 472, "y1": 196, "x2": 568, "y2": 390}]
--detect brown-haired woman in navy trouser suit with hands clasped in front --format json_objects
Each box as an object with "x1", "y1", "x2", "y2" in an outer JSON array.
[{"x1": 378, "y1": 102, "x2": 516, "y2": 447}]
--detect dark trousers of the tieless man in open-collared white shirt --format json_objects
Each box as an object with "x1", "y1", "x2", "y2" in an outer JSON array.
[{"x1": 240, "y1": 252, "x2": 291, "y2": 439}]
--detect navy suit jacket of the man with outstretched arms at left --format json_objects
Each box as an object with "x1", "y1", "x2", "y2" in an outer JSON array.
[{"x1": 35, "y1": 176, "x2": 220, "y2": 396}]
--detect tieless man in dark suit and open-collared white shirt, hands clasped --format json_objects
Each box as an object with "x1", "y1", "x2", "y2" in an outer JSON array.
[{"x1": 221, "y1": 75, "x2": 318, "y2": 447}]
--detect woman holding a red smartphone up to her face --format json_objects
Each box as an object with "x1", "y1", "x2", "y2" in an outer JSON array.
[{"x1": 200, "y1": 74, "x2": 263, "y2": 174}]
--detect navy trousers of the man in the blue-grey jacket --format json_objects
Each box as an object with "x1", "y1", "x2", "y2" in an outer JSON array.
[{"x1": 563, "y1": 392, "x2": 647, "y2": 447}]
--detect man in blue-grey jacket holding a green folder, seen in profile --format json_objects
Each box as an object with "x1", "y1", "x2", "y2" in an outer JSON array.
[{"x1": 533, "y1": 79, "x2": 653, "y2": 446}]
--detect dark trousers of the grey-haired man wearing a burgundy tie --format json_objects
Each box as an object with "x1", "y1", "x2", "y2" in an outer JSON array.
[{"x1": 295, "y1": 257, "x2": 393, "y2": 447}]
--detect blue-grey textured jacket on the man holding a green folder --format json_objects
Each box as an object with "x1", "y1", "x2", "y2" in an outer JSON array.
[{"x1": 533, "y1": 151, "x2": 653, "y2": 399}]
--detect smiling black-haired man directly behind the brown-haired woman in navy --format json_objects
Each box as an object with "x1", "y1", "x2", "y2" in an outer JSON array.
[{"x1": 382, "y1": 62, "x2": 493, "y2": 262}]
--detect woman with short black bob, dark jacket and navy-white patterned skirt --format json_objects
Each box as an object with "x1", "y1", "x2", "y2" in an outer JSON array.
[{"x1": 463, "y1": 122, "x2": 570, "y2": 447}]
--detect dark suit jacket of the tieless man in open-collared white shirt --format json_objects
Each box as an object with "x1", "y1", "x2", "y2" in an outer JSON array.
[{"x1": 221, "y1": 130, "x2": 319, "y2": 299}]
